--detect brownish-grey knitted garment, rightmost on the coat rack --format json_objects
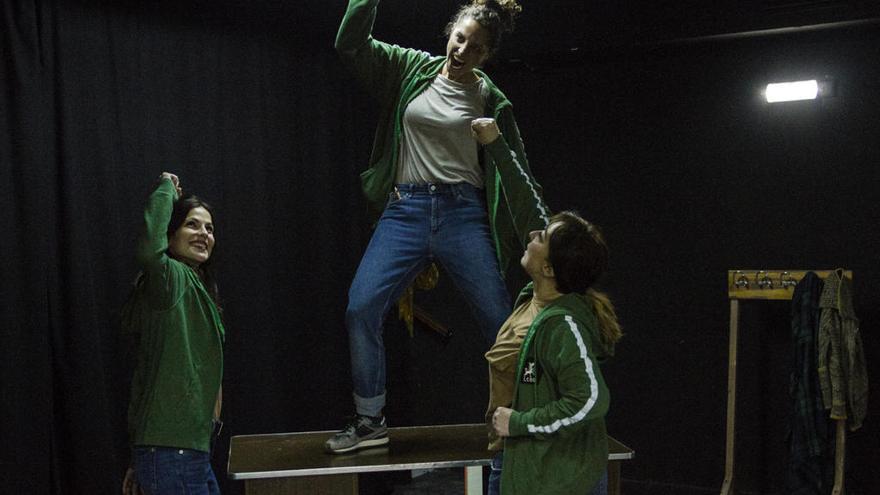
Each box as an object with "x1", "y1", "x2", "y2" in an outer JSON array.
[{"x1": 818, "y1": 269, "x2": 868, "y2": 431}]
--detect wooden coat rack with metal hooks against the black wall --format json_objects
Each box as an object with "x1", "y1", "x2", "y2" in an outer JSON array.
[{"x1": 721, "y1": 270, "x2": 852, "y2": 495}]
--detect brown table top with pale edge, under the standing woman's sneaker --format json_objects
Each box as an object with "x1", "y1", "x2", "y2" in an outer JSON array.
[{"x1": 227, "y1": 423, "x2": 633, "y2": 480}]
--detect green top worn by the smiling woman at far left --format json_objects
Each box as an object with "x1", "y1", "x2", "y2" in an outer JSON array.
[{"x1": 123, "y1": 180, "x2": 224, "y2": 452}]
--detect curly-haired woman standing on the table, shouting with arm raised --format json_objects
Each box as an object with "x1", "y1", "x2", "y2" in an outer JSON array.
[{"x1": 326, "y1": 0, "x2": 548, "y2": 453}]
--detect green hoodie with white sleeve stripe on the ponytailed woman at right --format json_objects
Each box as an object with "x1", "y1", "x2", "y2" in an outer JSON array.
[{"x1": 501, "y1": 286, "x2": 609, "y2": 495}]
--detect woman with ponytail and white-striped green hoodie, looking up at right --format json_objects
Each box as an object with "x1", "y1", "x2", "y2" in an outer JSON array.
[{"x1": 486, "y1": 212, "x2": 622, "y2": 495}]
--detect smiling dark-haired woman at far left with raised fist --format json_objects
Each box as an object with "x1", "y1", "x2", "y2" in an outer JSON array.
[{"x1": 122, "y1": 172, "x2": 224, "y2": 495}]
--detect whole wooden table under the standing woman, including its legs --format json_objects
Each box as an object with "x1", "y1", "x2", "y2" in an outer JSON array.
[{"x1": 227, "y1": 423, "x2": 634, "y2": 495}]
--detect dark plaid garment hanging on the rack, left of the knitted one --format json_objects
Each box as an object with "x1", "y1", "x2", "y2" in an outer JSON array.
[{"x1": 785, "y1": 272, "x2": 834, "y2": 495}]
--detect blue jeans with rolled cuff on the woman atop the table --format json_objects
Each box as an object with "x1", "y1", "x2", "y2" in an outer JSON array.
[{"x1": 345, "y1": 184, "x2": 511, "y2": 416}]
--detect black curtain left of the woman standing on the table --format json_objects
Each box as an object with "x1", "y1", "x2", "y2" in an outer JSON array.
[{"x1": 0, "y1": 2, "x2": 372, "y2": 494}]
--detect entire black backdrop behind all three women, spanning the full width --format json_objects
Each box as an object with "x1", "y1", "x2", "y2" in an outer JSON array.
[{"x1": 0, "y1": 0, "x2": 880, "y2": 494}]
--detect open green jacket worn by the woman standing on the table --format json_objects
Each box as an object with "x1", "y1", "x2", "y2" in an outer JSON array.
[{"x1": 336, "y1": 0, "x2": 550, "y2": 272}]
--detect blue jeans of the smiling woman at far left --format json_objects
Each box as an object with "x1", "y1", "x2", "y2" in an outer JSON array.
[{"x1": 134, "y1": 447, "x2": 220, "y2": 495}]
